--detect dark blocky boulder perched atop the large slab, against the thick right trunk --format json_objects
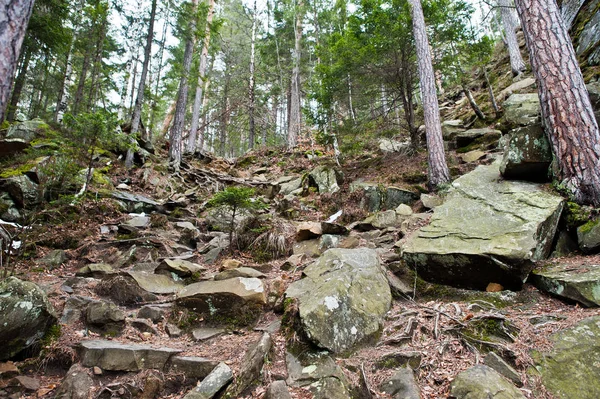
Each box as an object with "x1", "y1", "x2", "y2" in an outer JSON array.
[{"x1": 500, "y1": 123, "x2": 552, "y2": 181}]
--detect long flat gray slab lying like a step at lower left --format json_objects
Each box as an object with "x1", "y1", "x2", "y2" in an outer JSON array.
[{"x1": 79, "y1": 340, "x2": 181, "y2": 371}]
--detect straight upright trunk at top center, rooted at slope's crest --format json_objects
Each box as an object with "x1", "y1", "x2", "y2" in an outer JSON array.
[{"x1": 287, "y1": 0, "x2": 304, "y2": 148}]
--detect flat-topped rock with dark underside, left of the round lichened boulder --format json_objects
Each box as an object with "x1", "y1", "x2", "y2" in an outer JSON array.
[{"x1": 177, "y1": 277, "x2": 267, "y2": 325}]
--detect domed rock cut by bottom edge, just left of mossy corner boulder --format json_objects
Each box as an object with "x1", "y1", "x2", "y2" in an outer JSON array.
[{"x1": 450, "y1": 365, "x2": 525, "y2": 399}]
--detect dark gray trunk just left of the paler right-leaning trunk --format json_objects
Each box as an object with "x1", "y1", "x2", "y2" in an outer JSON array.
[{"x1": 169, "y1": 0, "x2": 198, "y2": 172}]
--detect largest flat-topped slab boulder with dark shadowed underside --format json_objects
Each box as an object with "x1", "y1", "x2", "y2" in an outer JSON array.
[{"x1": 402, "y1": 163, "x2": 563, "y2": 290}]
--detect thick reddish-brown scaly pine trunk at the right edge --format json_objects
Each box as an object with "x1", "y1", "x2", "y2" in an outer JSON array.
[{"x1": 516, "y1": 0, "x2": 600, "y2": 207}]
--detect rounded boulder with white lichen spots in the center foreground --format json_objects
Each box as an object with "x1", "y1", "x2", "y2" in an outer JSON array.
[{"x1": 286, "y1": 248, "x2": 392, "y2": 352}]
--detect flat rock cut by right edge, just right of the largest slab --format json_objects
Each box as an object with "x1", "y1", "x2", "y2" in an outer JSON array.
[{"x1": 530, "y1": 265, "x2": 600, "y2": 307}]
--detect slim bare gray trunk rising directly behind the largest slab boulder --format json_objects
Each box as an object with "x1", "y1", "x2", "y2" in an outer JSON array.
[{"x1": 409, "y1": 0, "x2": 450, "y2": 187}]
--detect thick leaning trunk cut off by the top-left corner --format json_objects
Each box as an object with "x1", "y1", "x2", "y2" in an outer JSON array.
[{"x1": 0, "y1": 0, "x2": 33, "y2": 122}]
